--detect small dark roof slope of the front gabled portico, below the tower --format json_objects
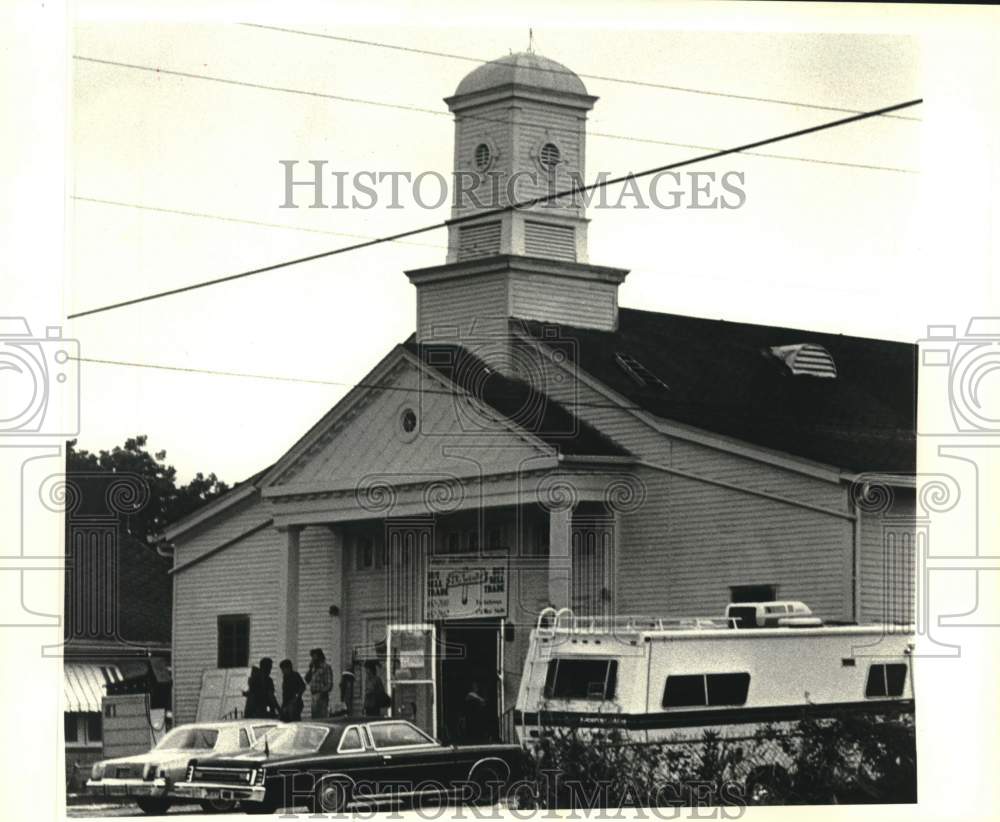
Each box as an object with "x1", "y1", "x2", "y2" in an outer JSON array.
[{"x1": 403, "y1": 336, "x2": 631, "y2": 457}]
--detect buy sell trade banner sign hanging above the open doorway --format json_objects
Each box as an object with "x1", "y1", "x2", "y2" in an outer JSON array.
[{"x1": 424, "y1": 557, "x2": 508, "y2": 622}]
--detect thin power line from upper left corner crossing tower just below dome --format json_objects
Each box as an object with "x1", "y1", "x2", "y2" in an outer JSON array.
[{"x1": 73, "y1": 54, "x2": 917, "y2": 174}]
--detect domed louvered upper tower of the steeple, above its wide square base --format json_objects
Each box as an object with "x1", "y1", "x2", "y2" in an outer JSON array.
[{"x1": 445, "y1": 52, "x2": 597, "y2": 263}]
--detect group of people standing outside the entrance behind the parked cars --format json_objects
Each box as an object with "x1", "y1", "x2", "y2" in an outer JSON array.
[{"x1": 243, "y1": 648, "x2": 392, "y2": 722}]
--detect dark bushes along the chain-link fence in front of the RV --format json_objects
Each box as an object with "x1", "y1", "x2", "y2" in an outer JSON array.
[{"x1": 517, "y1": 714, "x2": 916, "y2": 811}]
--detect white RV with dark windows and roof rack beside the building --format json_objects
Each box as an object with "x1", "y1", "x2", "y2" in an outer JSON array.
[{"x1": 514, "y1": 602, "x2": 913, "y2": 745}]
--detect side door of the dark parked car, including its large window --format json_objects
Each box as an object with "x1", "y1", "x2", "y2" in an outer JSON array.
[{"x1": 368, "y1": 719, "x2": 455, "y2": 793}]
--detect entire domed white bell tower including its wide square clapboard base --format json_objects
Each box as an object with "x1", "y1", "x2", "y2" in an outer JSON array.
[{"x1": 406, "y1": 52, "x2": 628, "y2": 348}]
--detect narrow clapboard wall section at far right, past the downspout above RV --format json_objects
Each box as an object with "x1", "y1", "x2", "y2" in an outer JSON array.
[{"x1": 860, "y1": 496, "x2": 925, "y2": 624}]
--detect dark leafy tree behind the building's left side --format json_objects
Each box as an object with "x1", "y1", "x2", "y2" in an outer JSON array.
[{"x1": 66, "y1": 435, "x2": 229, "y2": 543}]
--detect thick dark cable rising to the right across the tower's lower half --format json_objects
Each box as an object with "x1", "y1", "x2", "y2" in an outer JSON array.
[{"x1": 67, "y1": 99, "x2": 923, "y2": 320}]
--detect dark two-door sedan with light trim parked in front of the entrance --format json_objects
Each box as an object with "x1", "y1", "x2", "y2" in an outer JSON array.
[{"x1": 176, "y1": 717, "x2": 522, "y2": 813}]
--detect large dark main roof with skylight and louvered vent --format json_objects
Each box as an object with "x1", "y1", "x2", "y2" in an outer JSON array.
[{"x1": 511, "y1": 308, "x2": 917, "y2": 473}]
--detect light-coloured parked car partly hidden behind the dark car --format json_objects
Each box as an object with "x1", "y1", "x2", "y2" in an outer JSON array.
[{"x1": 87, "y1": 719, "x2": 278, "y2": 815}]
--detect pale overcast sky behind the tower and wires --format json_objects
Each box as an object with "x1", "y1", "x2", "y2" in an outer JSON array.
[{"x1": 64, "y1": 7, "x2": 992, "y2": 482}]
